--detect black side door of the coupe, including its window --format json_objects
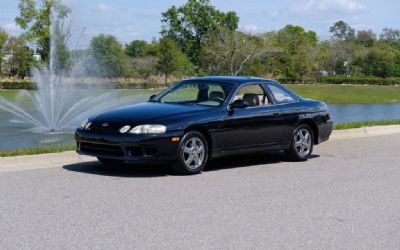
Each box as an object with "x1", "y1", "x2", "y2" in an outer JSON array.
[{"x1": 220, "y1": 83, "x2": 283, "y2": 150}]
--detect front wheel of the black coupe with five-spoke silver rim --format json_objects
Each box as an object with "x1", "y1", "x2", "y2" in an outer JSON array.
[{"x1": 174, "y1": 131, "x2": 208, "y2": 174}]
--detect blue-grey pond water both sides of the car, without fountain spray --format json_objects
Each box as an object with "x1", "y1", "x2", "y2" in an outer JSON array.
[{"x1": 0, "y1": 103, "x2": 400, "y2": 150}]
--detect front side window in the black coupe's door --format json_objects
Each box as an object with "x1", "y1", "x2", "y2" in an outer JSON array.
[{"x1": 233, "y1": 84, "x2": 270, "y2": 107}]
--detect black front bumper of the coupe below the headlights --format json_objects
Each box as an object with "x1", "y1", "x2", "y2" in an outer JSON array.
[{"x1": 75, "y1": 129, "x2": 183, "y2": 163}]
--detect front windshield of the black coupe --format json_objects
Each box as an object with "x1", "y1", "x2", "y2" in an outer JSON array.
[{"x1": 154, "y1": 81, "x2": 234, "y2": 107}]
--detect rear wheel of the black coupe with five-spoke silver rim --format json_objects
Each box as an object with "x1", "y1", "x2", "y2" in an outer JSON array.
[{"x1": 285, "y1": 124, "x2": 314, "y2": 161}]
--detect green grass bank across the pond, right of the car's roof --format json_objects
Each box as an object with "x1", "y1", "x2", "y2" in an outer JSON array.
[{"x1": 286, "y1": 84, "x2": 400, "y2": 104}]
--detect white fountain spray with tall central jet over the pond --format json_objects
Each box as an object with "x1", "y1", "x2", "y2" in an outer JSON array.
[{"x1": 0, "y1": 4, "x2": 139, "y2": 132}]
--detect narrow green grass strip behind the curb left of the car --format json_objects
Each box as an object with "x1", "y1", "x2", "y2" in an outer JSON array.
[{"x1": 0, "y1": 144, "x2": 76, "y2": 157}]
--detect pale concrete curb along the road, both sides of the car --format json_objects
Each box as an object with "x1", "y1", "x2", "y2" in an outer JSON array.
[{"x1": 0, "y1": 125, "x2": 400, "y2": 173}]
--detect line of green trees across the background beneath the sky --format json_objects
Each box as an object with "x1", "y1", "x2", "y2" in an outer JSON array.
[{"x1": 0, "y1": 0, "x2": 400, "y2": 82}]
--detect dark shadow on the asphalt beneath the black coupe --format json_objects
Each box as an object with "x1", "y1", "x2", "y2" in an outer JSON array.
[{"x1": 63, "y1": 152, "x2": 319, "y2": 178}]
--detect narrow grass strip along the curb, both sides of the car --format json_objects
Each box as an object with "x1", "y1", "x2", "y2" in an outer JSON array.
[{"x1": 0, "y1": 120, "x2": 400, "y2": 157}]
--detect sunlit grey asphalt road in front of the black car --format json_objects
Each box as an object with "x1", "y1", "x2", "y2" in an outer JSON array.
[{"x1": 0, "y1": 135, "x2": 400, "y2": 249}]
